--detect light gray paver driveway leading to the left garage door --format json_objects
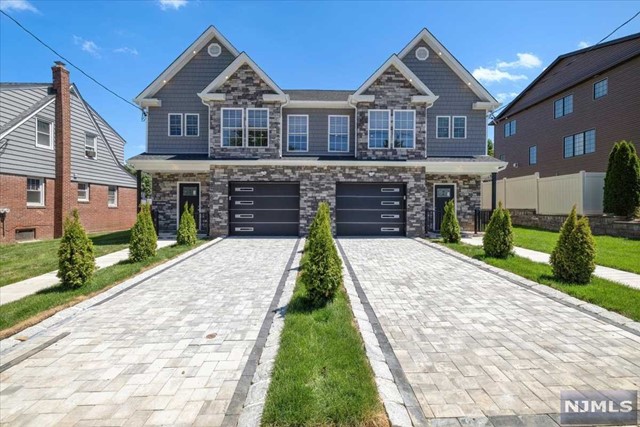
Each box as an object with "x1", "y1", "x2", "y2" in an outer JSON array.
[{"x1": 0, "y1": 239, "x2": 296, "y2": 426}]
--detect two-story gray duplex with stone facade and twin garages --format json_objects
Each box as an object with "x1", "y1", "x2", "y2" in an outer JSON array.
[{"x1": 130, "y1": 27, "x2": 504, "y2": 236}]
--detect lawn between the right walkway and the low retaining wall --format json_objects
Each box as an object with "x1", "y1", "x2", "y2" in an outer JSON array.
[{"x1": 513, "y1": 227, "x2": 640, "y2": 274}]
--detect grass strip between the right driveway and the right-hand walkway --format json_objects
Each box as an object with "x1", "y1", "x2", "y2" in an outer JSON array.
[{"x1": 442, "y1": 243, "x2": 640, "y2": 321}]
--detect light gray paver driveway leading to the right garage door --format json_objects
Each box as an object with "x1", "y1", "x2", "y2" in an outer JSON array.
[{"x1": 339, "y1": 239, "x2": 640, "y2": 425}]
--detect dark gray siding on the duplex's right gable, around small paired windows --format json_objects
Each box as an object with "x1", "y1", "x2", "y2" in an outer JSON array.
[{"x1": 402, "y1": 41, "x2": 487, "y2": 157}]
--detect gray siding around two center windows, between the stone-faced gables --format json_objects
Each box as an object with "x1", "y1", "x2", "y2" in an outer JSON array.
[{"x1": 282, "y1": 108, "x2": 355, "y2": 156}]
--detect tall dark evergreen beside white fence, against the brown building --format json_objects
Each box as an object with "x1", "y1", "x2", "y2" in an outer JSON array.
[{"x1": 603, "y1": 140, "x2": 640, "y2": 217}]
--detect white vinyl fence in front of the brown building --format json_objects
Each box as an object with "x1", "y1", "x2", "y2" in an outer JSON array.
[{"x1": 482, "y1": 171, "x2": 605, "y2": 215}]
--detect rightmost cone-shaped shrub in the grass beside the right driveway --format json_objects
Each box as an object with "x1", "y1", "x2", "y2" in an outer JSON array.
[{"x1": 550, "y1": 206, "x2": 596, "y2": 284}]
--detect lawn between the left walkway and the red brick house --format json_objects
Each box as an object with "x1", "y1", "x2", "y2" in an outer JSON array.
[{"x1": 0, "y1": 230, "x2": 131, "y2": 286}]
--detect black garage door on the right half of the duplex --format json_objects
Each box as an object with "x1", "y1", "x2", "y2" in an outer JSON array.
[{"x1": 336, "y1": 183, "x2": 406, "y2": 236}]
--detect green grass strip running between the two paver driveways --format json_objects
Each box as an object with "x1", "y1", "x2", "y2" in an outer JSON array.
[{"x1": 262, "y1": 279, "x2": 388, "y2": 426}]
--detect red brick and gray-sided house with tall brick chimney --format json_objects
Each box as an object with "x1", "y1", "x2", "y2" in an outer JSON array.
[{"x1": 0, "y1": 62, "x2": 137, "y2": 243}]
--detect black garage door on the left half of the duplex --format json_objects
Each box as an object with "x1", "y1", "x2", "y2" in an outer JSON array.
[{"x1": 229, "y1": 182, "x2": 300, "y2": 236}]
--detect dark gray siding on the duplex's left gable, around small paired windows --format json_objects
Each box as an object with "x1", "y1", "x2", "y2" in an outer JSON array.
[{"x1": 147, "y1": 39, "x2": 235, "y2": 153}]
